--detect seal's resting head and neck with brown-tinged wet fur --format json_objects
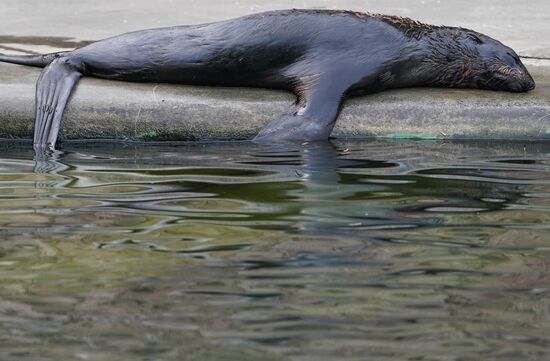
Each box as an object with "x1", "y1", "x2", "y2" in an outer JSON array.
[{"x1": 429, "y1": 28, "x2": 535, "y2": 93}]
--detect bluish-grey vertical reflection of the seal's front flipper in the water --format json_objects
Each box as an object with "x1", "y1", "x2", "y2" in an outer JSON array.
[{"x1": 247, "y1": 142, "x2": 392, "y2": 234}]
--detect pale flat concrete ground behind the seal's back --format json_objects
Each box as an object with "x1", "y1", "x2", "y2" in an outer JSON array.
[{"x1": 0, "y1": 0, "x2": 550, "y2": 57}]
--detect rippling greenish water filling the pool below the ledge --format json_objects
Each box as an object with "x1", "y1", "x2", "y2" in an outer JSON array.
[{"x1": 0, "y1": 142, "x2": 550, "y2": 361}]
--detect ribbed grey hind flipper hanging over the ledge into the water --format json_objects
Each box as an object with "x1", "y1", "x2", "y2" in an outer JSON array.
[{"x1": 34, "y1": 58, "x2": 82, "y2": 149}]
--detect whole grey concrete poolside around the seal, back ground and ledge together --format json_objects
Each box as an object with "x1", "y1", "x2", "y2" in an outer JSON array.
[{"x1": 0, "y1": 0, "x2": 550, "y2": 140}]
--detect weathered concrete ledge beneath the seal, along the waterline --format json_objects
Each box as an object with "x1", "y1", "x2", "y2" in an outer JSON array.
[{"x1": 0, "y1": 60, "x2": 550, "y2": 140}]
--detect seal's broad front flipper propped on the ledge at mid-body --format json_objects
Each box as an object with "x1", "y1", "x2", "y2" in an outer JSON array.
[{"x1": 252, "y1": 77, "x2": 350, "y2": 143}]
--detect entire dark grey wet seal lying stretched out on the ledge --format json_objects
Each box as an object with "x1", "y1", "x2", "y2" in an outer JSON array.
[{"x1": 0, "y1": 10, "x2": 535, "y2": 148}]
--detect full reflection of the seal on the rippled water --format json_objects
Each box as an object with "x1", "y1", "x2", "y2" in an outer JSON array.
[{"x1": 28, "y1": 141, "x2": 527, "y2": 235}]
